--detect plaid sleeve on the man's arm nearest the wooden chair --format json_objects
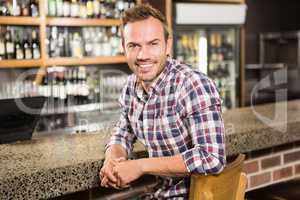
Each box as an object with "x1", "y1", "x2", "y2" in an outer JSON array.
[{"x1": 178, "y1": 74, "x2": 226, "y2": 174}]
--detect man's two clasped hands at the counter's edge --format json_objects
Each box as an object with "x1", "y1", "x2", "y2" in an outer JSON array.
[{"x1": 99, "y1": 157, "x2": 143, "y2": 189}]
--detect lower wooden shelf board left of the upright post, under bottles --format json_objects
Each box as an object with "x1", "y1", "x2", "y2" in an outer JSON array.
[{"x1": 0, "y1": 59, "x2": 42, "y2": 68}]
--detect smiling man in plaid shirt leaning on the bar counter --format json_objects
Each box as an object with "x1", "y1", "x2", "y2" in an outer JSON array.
[{"x1": 100, "y1": 5, "x2": 225, "y2": 199}]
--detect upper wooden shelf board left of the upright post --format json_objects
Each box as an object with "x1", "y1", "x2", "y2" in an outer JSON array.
[{"x1": 0, "y1": 16, "x2": 41, "y2": 26}]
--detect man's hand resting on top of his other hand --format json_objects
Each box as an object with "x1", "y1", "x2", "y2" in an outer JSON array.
[{"x1": 113, "y1": 160, "x2": 143, "y2": 188}]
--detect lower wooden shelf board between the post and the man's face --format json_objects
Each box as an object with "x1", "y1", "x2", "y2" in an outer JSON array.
[{"x1": 46, "y1": 56, "x2": 126, "y2": 66}]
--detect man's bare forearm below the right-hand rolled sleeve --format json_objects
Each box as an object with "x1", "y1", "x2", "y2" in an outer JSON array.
[{"x1": 136, "y1": 154, "x2": 189, "y2": 176}]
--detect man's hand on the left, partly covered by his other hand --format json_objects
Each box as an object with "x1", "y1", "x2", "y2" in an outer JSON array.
[{"x1": 99, "y1": 157, "x2": 126, "y2": 189}]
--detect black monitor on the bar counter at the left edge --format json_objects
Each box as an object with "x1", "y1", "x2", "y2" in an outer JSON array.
[{"x1": 0, "y1": 97, "x2": 46, "y2": 144}]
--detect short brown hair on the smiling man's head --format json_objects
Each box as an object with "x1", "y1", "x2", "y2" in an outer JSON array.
[{"x1": 121, "y1": 3, "x2": 170, "y2": 40}]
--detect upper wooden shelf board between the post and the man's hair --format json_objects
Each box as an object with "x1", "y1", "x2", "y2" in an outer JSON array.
[{"x1": 46, "y1": 17, "x2": 121, "y2": 26}]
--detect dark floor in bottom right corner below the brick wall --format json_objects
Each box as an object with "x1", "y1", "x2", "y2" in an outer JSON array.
[{"x1": 246, "y1": 179, "x2": 300, "y2": 200}]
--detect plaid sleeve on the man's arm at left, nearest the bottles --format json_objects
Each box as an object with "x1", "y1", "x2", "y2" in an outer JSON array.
[{"x1": 105, "y1": 83, "x2": 136, "y2": 156}]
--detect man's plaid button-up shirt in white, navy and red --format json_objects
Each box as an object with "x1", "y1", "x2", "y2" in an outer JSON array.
[{"x1": 106, "y1": 59, "x2": 225, "y2": 199}]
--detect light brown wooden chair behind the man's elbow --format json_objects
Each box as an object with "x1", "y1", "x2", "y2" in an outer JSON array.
[{"x1": 189, "y1": 154, "x2": 247, "y2": 200}]
